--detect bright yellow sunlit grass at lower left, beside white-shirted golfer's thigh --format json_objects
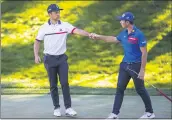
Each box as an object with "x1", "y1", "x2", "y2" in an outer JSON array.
[{"x1": 1, "y1": 64, "x2": 49, "y2": 88}]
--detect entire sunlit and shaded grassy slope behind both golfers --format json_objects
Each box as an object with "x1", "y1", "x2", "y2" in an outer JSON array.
[{"x1": 1, "y1": 1, "x2": 172, "y2": 92}]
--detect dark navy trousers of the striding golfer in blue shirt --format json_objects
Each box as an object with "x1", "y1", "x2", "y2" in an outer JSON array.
[{"x1": 112, "y1": 62, "x2": 153, "y2": 115}]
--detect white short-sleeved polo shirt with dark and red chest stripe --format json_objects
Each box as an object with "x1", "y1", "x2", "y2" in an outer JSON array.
[{"x1": 36, "y1": 20, "x2": 76, "y2": 55}]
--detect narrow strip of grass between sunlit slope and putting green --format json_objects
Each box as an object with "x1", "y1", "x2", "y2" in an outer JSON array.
[{"x1": 2, "y1": 86, "x2": 172, "y2": 96}]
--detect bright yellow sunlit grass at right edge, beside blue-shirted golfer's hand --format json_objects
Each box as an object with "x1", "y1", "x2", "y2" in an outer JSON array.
[{"x1": 145, "y1": 53, "x2": 172, "y2": 87}]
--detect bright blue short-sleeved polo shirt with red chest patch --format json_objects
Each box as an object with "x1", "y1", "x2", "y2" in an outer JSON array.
[{"x1": 117, "y1": 26, "x2": 147, "y2": 62}]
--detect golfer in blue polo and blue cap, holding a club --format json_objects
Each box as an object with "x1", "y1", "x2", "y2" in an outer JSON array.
[{"x1": 90, "y1": 12, "x2": 155, "y2": 119}]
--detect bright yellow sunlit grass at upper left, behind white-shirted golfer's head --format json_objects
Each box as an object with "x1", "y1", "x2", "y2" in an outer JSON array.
[{"x1": 1, "y1": 1, "x2": 96, "y2": 46}]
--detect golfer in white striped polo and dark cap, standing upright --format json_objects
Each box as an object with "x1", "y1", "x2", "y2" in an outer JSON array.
[{"x1": 34, "y1": 4, "x2": 89, "y2": 116}]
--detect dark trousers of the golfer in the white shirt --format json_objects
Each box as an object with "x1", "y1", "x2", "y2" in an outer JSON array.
[{"x1": 44, "y1": 54, "x2": 71, "y2": 109}]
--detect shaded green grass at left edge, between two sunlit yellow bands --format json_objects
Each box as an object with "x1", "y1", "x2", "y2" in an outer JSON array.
[{"x1": 1, "y1": 44, "x2": 39, "y2": 75}]
